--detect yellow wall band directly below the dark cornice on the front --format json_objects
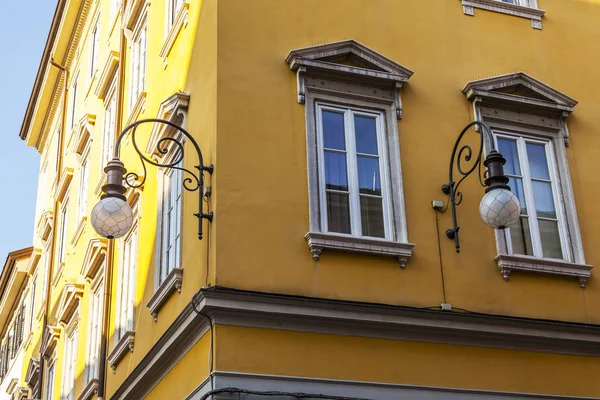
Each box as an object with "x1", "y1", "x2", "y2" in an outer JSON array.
[{"x1": 215, "y1": 326, "x2": 600, "y2": 397}]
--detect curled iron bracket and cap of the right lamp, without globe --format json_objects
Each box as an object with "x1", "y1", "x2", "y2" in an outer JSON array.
[{"x1": 442, "y1": 121, "x2": 510, "y2": 253}]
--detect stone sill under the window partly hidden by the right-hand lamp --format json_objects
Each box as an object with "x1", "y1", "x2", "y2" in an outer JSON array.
[{"x1": 495, "y1": 254, "x2": 594, "y2": 289}]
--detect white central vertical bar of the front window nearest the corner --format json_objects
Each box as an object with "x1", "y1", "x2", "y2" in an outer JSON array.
[{"x1": 344, "y1": 110, "x2": 362, "y2": 237}]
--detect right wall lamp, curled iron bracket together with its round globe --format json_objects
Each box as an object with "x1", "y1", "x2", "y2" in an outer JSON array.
[{"x1": 442, "y1": 121, "x2": 521, "y2": 253}]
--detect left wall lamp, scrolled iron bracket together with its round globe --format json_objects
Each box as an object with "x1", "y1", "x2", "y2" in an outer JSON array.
[{"x1": 91, "y1": 118, "x2": 214, "y2": 239}]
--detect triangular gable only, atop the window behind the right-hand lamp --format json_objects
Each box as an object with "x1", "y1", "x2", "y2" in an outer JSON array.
[{"x1": 463, "y1": 72, "x2": 577, "y2": 113}]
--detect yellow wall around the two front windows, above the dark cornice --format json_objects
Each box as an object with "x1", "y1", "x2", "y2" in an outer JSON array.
[{"x1": 216, "y1": 0, "x2": 600, "y2": 323}]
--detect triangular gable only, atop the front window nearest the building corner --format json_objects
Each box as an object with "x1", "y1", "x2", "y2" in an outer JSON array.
[{"x1": 285, "y1": 39, "x2": 413, "y2": 82}]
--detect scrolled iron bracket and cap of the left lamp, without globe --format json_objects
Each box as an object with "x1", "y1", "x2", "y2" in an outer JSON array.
[{"x1": 102, "y1": 118, "x2": 214, "y2": 240}]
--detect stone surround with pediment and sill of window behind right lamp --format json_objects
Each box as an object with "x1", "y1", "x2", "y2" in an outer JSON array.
[{"x1": 463, "y1": 72, "x2": 593, "y2": 289}]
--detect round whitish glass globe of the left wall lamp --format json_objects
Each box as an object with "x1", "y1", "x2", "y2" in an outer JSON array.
[{"x1": 91, "y1": 197, "x2": 133, "y2": 239}]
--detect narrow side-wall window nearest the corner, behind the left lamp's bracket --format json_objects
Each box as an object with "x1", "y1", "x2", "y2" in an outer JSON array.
[{"x1": 159, "y1": 165, "x2": 182, "y2": 284}]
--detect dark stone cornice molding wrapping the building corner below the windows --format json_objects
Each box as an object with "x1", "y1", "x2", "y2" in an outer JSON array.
[{"x1": 112, "y1": 287, "x2": 600, "y2": 399}]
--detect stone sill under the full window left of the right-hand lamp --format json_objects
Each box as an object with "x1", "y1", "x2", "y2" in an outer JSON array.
[{"x1": 304, "y1": 232, "x2": 415, "y2": 269}]
